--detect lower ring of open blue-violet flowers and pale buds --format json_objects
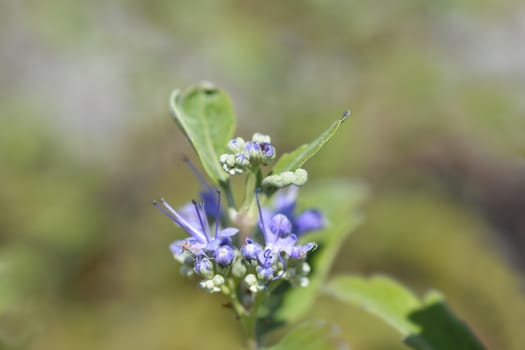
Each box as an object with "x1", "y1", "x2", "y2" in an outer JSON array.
[{"x1": 153, "y1": 188, "x2": 325, "y2": 294}]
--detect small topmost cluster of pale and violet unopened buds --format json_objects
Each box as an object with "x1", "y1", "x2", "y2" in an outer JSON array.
[{"x1": 219, "y1": 133, "x2": 275, "y2": 175}]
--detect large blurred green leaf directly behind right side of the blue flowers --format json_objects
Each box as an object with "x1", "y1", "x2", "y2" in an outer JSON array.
[{"x1": 274, "y1": 180, "x2": 366, "y2": 322}]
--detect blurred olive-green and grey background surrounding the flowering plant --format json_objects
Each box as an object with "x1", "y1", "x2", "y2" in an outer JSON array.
[{"x1": 0, "y1": 0, "x2": 525, "y2": 350}]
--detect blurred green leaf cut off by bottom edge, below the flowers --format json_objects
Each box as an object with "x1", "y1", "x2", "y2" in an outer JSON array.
[{"x1": 267, "y1": 321, "x2": 341, "y2": 350}]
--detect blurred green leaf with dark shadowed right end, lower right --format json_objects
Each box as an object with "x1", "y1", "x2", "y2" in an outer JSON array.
[{"x1": 326, "y1": 276, "x2": 484, "y2": 350}]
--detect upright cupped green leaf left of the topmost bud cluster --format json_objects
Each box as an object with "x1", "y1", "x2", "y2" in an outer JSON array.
[{"x1": 170, "y1": 85, "x2": 235, "y2": 184}]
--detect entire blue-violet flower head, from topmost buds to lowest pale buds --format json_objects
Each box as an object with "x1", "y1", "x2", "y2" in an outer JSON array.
[{"x1": 153, "y1": 129, "x2": 326, "y2": 317}]
